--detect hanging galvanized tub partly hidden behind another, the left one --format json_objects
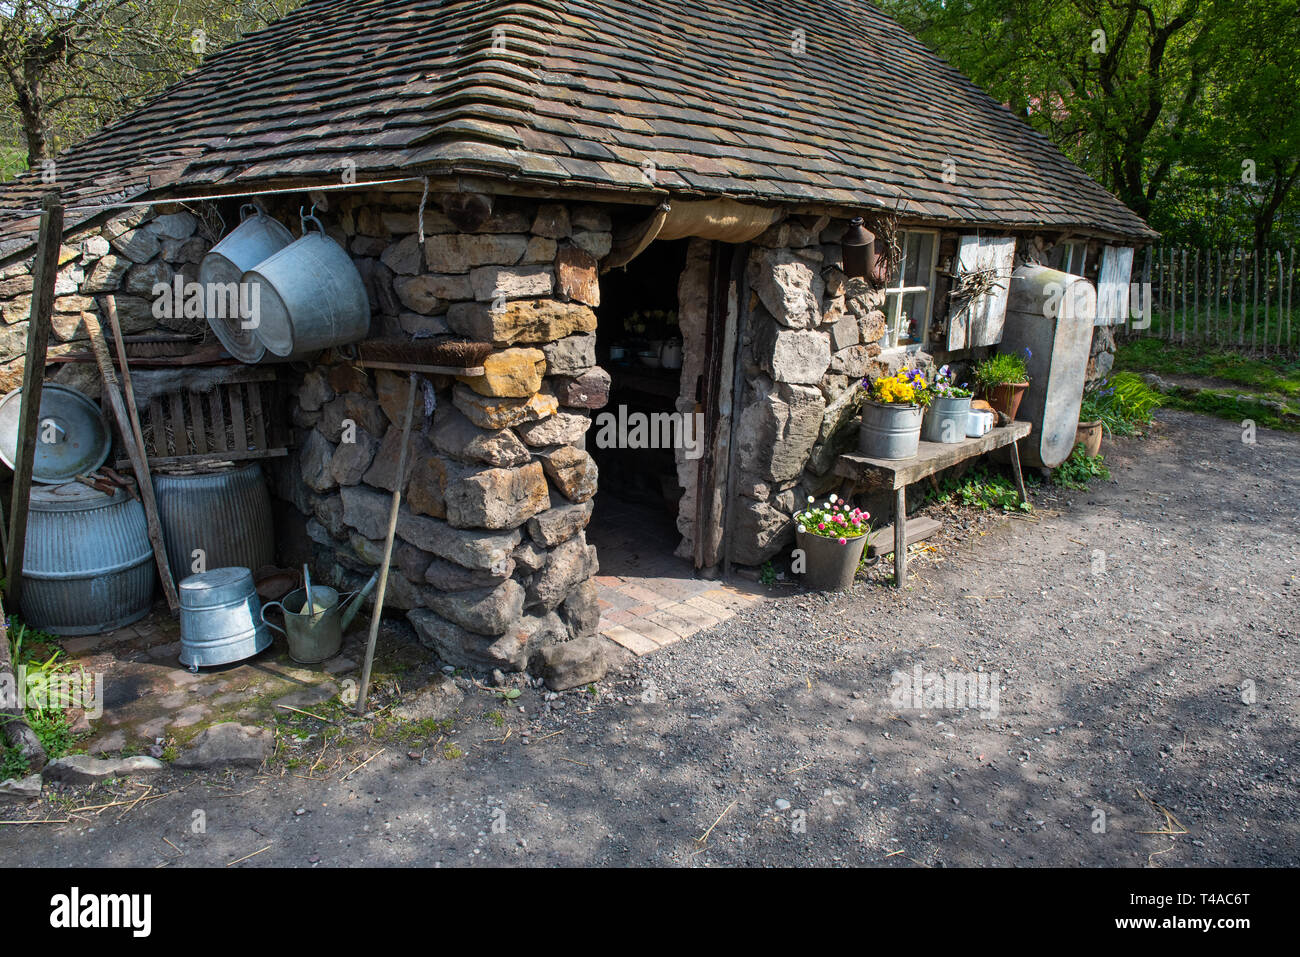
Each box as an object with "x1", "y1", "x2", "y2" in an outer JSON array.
[{"x1": 199, "y1": 203, "x2": 294, "y2": 364}]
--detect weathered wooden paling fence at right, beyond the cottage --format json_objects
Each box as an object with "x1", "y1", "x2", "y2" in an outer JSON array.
[{"x1": 1125, "y1": 247, "x2": 1300, "y2": 355}]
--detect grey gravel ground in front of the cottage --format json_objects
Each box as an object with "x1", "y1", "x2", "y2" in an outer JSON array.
[{"x1": 0, "y1": 412, "x2": 1300, "y2": 867}]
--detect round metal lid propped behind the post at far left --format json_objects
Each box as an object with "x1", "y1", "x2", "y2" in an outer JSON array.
[{"x1": 0, "y1": 382, "x2": 113, "y2": 485}]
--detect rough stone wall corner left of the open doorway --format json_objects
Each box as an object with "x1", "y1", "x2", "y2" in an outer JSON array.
[{"x1": 282, "y1": 196, "x2": 611, "y2": 670}]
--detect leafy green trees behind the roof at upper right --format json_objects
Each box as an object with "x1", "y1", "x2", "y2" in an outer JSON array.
[{"x1": 880, "y1": 0, "x2": 1300, "y2": 244}]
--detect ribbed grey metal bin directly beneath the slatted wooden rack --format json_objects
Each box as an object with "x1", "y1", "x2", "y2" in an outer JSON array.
[{"x1": 153, "y1": 462, "x2": 276, "y2": 575}]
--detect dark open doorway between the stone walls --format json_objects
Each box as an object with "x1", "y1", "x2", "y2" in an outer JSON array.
[{"x1": 588, "y1": 239, "x2": 690, "y2": 576}]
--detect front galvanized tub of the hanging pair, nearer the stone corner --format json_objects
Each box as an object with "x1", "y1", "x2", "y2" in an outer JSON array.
[{"x1": 243, "y1": 209, "x2": 371, "y2": 359}]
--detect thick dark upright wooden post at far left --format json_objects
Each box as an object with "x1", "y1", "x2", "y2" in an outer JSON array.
[{"x1": 5, "y1": 194, "x2": 64, "y2": 611}]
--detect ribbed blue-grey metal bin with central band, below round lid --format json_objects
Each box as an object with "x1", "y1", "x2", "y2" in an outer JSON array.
[{"x1": 22, "y1": 482, "x2": 153, "y2": 635}]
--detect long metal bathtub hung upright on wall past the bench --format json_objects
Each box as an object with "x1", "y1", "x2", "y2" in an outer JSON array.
[{"x1": 998, "y1": 265, "x2": 1097, "y2": 468}]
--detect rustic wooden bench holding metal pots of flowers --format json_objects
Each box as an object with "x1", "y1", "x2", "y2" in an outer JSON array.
[{"x1": 835, "y1": 421, "x2": 1032, "y2": 588}]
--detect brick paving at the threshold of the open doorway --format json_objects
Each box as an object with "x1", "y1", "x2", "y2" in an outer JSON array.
[{"x1": 586, "y1": 494, "x2": 764, "y2": 655}]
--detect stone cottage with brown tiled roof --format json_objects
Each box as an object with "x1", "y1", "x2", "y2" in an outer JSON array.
[{"x1": 0, "y1": 0, "x2": 1153, "y2": 670}]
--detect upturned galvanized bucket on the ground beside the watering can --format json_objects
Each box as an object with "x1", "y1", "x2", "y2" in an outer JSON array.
[{"x1": 177, "y1": 568, "x2": 272, "y2": 668}]
